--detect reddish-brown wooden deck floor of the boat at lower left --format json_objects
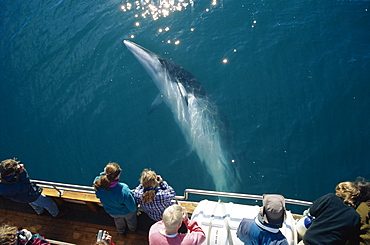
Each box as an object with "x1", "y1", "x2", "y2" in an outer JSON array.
[{"x1": 0, "y1": 197, "x2": 154, "y2": 245}]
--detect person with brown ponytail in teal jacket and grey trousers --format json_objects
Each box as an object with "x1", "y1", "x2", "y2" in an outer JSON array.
[{"x1": 94, "y1": 162, "x2": 137, "y2": 236}]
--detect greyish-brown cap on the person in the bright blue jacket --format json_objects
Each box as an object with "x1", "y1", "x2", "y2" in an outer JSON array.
[{"x1": 262, "y1": 194, "x2": 285, "y2": 228}]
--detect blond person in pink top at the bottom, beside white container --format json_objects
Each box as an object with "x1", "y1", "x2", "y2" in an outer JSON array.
[{"x1": 149, "y1": 204, "x2": 206, "y2": 245}]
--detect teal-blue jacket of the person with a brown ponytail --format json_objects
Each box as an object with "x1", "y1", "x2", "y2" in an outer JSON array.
[{"x1": 94, "y1": 176, "x2": 137, "y2": 215}]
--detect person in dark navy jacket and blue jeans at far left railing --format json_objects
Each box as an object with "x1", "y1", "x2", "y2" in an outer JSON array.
[{"x1": 0, "y1": 159, "x2": 68, "y2": 218}]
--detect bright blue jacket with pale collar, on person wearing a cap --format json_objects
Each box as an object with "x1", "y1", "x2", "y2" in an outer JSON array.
[{"x1": 236, "y1": 218, "x2": 288, "y2": 245}]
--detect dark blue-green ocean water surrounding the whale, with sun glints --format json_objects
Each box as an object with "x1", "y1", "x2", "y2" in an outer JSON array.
[{"x1": 0, "y1": 0, "x2": 370, "y2": 209}]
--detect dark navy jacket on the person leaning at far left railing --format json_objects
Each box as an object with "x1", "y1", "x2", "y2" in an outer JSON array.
[{"x1": 0, "y1": 170, "x2": 42, "y2": 203}]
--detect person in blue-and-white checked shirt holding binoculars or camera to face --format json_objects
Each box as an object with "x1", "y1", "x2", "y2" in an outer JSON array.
[{"x1": 134, "y1": 169, "x2": 176, "y2": 221}]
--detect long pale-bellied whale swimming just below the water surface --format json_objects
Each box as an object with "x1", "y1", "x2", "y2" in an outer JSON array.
[{"x1": 123, "y1": 40, "x2": 239, "y2": 191}]
